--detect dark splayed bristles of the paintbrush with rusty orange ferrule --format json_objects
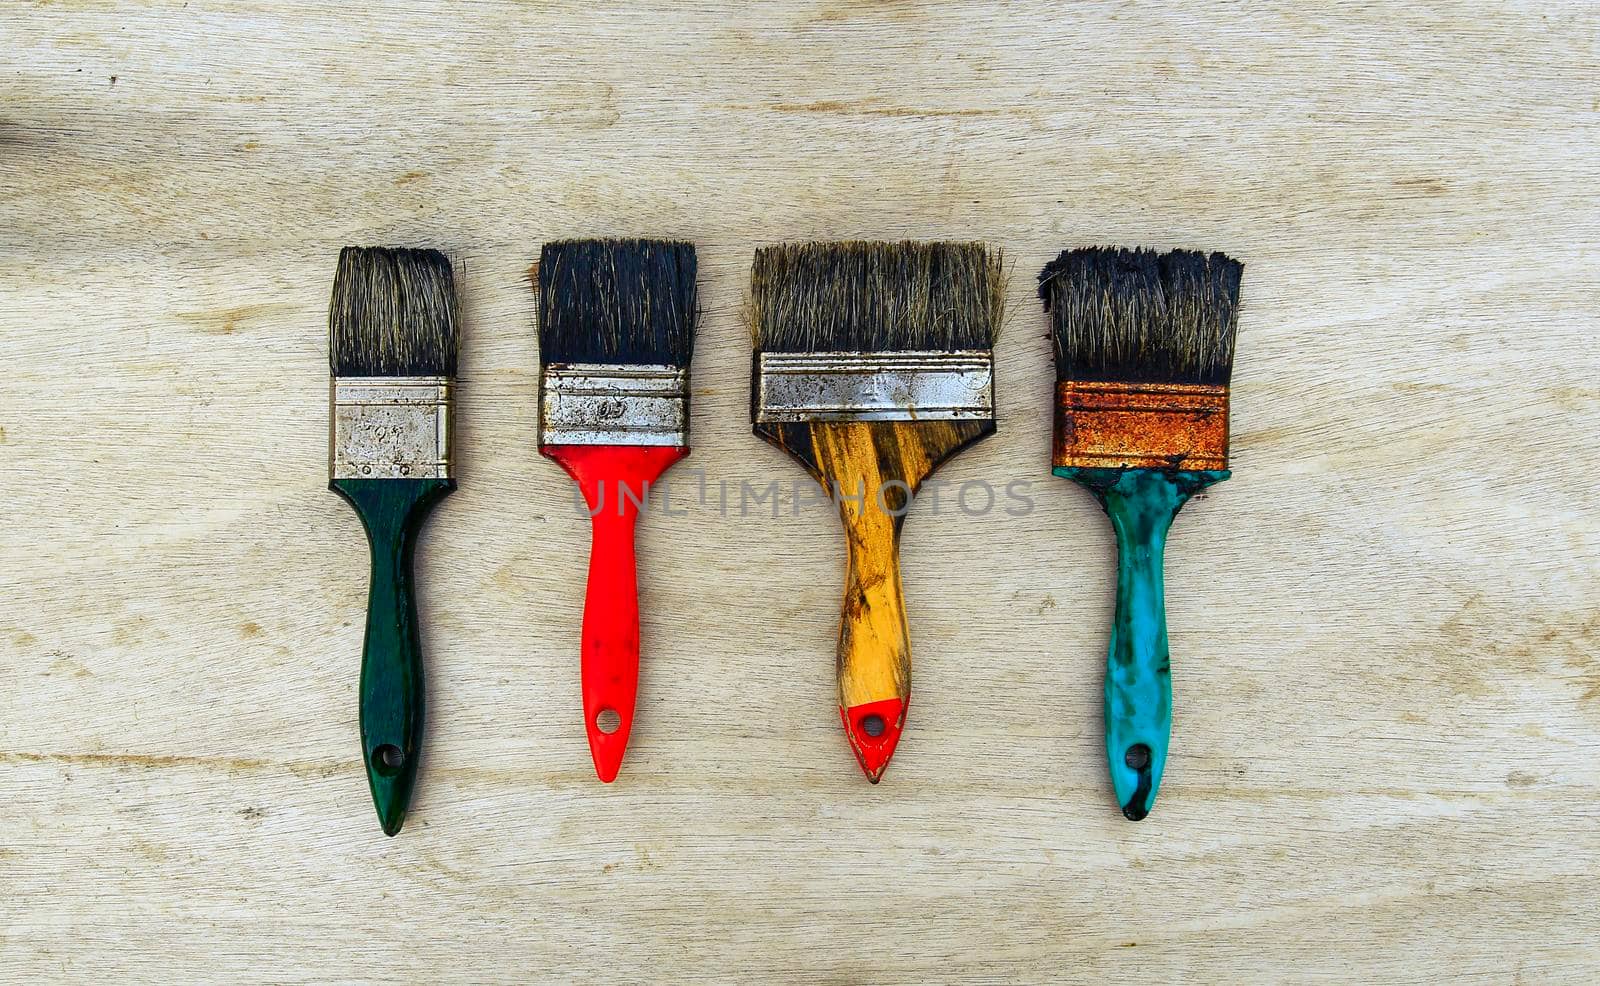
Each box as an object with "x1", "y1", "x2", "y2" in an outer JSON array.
[{"x1": 1038, "y1": 248, "x2": 1245, "y2": 386}]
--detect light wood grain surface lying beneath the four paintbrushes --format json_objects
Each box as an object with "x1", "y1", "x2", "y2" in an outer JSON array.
[{"x1": 0, "y1": 0, "x2": 1600, "y2": 984}]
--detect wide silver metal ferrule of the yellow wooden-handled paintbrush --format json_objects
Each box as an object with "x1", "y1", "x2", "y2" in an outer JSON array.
[{"x1": 755, "y1": 349, "x2": 995, "y2": 423}]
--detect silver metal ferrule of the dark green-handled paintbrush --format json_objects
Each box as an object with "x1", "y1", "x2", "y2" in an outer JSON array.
[{"x1": 328, "y1": 376, "x2": 451, "y2": 479}]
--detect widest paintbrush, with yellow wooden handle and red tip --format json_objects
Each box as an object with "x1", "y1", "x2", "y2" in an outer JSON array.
[{"x1": 750, "y1": 243, "x2": 1005, "y2": 783}]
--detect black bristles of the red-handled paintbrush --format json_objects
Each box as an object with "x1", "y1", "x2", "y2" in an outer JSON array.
[{"x1": 539, "y1": 240, "x2": 698, "y2": 367}]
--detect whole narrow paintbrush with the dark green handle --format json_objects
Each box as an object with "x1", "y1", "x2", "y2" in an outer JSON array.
[{"x1": 328, "y1": 247, "x2": 456, "y2": 836}]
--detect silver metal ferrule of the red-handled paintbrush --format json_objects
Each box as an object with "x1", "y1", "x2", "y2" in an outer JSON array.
[{"x1": 539, "y1": 363, "x2": 690, "y2": 445}]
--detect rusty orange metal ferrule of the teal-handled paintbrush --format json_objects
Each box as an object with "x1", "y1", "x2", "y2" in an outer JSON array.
[{"x1": 1053, "y1": 379, "x2": 1227, "y2": 469}]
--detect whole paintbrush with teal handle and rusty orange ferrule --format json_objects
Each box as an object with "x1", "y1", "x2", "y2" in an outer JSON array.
[{"x1": 1038, "y1": 248, "x2": 1243, "y2": 821}]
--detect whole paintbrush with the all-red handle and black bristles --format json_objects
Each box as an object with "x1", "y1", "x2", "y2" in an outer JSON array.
[{"x1": 538, "y1": 240, "x2": 696, "y2": 783}]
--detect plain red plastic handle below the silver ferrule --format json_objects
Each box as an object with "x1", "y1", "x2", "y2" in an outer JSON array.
[{"x1": 539, "y1": 445, "x2": 690, "y2": 784}]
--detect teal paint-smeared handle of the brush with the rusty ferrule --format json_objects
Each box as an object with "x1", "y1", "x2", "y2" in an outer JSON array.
[{"x1": 1056, "y1": 467, "x2": 1229, "y2": 821}]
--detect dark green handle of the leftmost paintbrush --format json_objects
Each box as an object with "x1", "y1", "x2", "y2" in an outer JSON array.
[{"x1": 328, "y1": 479, "x2": 456, "y2": 836}]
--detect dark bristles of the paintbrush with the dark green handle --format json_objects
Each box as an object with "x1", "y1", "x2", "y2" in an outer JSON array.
[{"x1": 328, "y1": 247, "x2": 458, "y2": 376}]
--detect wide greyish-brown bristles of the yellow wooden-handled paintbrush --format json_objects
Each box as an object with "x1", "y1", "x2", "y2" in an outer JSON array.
[{"x1": 750, "y1": 242, "x2": 1005, "y2": 352}]
